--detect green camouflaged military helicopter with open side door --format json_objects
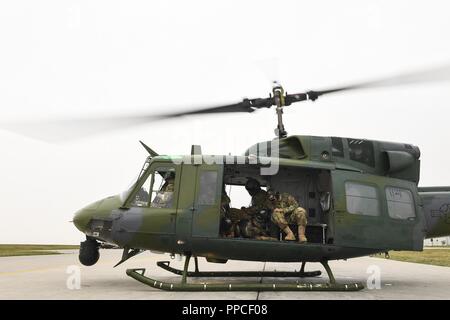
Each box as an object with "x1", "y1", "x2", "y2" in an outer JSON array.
[{"x1": 68, "y1": 68, "x2": 450, "y2": 291}]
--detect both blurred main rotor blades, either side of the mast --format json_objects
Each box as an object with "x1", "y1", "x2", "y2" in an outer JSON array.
[{"x1": 0, "y1": 65, "x2": 450, "y2": 142}]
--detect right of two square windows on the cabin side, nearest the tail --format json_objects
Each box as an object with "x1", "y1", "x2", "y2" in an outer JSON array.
[{"x1": 386, "y1": 187, "x2": 416, "y2": 220}]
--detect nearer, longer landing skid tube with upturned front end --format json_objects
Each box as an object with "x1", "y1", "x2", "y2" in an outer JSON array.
[{"x1": 127, "y1": 269, "x2": 364, "y2": 291}]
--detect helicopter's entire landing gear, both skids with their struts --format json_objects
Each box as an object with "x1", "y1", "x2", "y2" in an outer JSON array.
[{"x1": 127, "y1": 256, "x2": 364, "y2": 291}]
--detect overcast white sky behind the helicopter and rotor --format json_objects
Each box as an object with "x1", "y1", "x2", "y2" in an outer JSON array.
[{"x1": 0, "y1": 0, "x2": 450, "y2": 243}]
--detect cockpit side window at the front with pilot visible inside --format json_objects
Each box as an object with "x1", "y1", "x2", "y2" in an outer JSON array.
[{"x1": 131, "y1": 168, "x2": 175, "y2": 208}]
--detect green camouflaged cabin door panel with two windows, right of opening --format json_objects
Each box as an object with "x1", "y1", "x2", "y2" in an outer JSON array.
[{"x1": 331, "y1": 170, "x2": 424, "y2": 250}]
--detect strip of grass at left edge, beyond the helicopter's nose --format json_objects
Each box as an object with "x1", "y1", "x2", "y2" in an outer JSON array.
[{"x1": 0, "y1": 244, "x2": 79, "y2": 257}]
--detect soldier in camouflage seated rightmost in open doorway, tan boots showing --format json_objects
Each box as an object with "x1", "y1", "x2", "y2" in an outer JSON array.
[{"x1": 269, "y1": 191, "x2": 308, "y2": 243}]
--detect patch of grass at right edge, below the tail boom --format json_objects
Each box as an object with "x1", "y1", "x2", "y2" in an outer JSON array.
[{"x1": 374, "y1": 247, "x2": 450, "y2": 267}]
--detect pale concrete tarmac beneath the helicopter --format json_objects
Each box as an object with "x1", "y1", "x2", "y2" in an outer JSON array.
[{"x1": 0, "y1": 249, "x2": 450, "y2": 300}]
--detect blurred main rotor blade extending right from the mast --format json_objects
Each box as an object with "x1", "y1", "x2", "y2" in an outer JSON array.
[{"x1": 286, "y1": 65, "x2": 450, "y2": 106}]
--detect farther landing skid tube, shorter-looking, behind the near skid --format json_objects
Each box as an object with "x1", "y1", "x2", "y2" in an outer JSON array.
[{"x1": 156, "y1": 261, "x2": 322, "y2": 278}]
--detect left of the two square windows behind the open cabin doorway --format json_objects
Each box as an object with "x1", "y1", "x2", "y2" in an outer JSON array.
[{"x1": 345, "y1": 182, "x2": 380, "y2": 216}]
